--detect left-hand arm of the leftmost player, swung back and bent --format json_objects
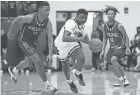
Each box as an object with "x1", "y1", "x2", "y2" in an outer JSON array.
[{"x1": 7, "y1": 15, "x2": 33, "y2": 40}]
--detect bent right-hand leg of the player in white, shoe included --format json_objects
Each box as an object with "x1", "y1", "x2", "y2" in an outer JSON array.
[{"x1": 71, "y1": 48, "x2": 85, "y2": 86}]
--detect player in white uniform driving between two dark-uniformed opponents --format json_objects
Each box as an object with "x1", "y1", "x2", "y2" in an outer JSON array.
[{"x1": 55, "y1": 9, "x2": 89, "y2": 93}]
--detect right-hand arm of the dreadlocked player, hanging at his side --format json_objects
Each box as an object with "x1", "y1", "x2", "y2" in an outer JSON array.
[{"x1": 118, "y1": 24, "x2": 129, "y2": 48}]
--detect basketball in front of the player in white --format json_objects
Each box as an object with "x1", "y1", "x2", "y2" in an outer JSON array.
[{"x1": 89, "y1": 38, "x2": 103, "y2": 53}]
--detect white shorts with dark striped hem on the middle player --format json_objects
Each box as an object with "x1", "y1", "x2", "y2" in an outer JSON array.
[{"x1": 55, "y1": 42, "x2": 81, "y2": 61}]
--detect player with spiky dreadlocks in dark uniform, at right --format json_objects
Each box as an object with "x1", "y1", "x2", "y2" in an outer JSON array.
[{"x1": 101, "y1": 6, "x2": 130, "y2": 86}]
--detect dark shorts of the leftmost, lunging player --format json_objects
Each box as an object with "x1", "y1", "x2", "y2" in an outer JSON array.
[{"x1": 18, "y1": 41, "x2": 36, "y2": 56}]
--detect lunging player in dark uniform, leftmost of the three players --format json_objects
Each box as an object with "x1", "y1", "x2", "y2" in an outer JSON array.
[{"x1": 8, "y1": 1, "x2": 57, "y2": 94}]
